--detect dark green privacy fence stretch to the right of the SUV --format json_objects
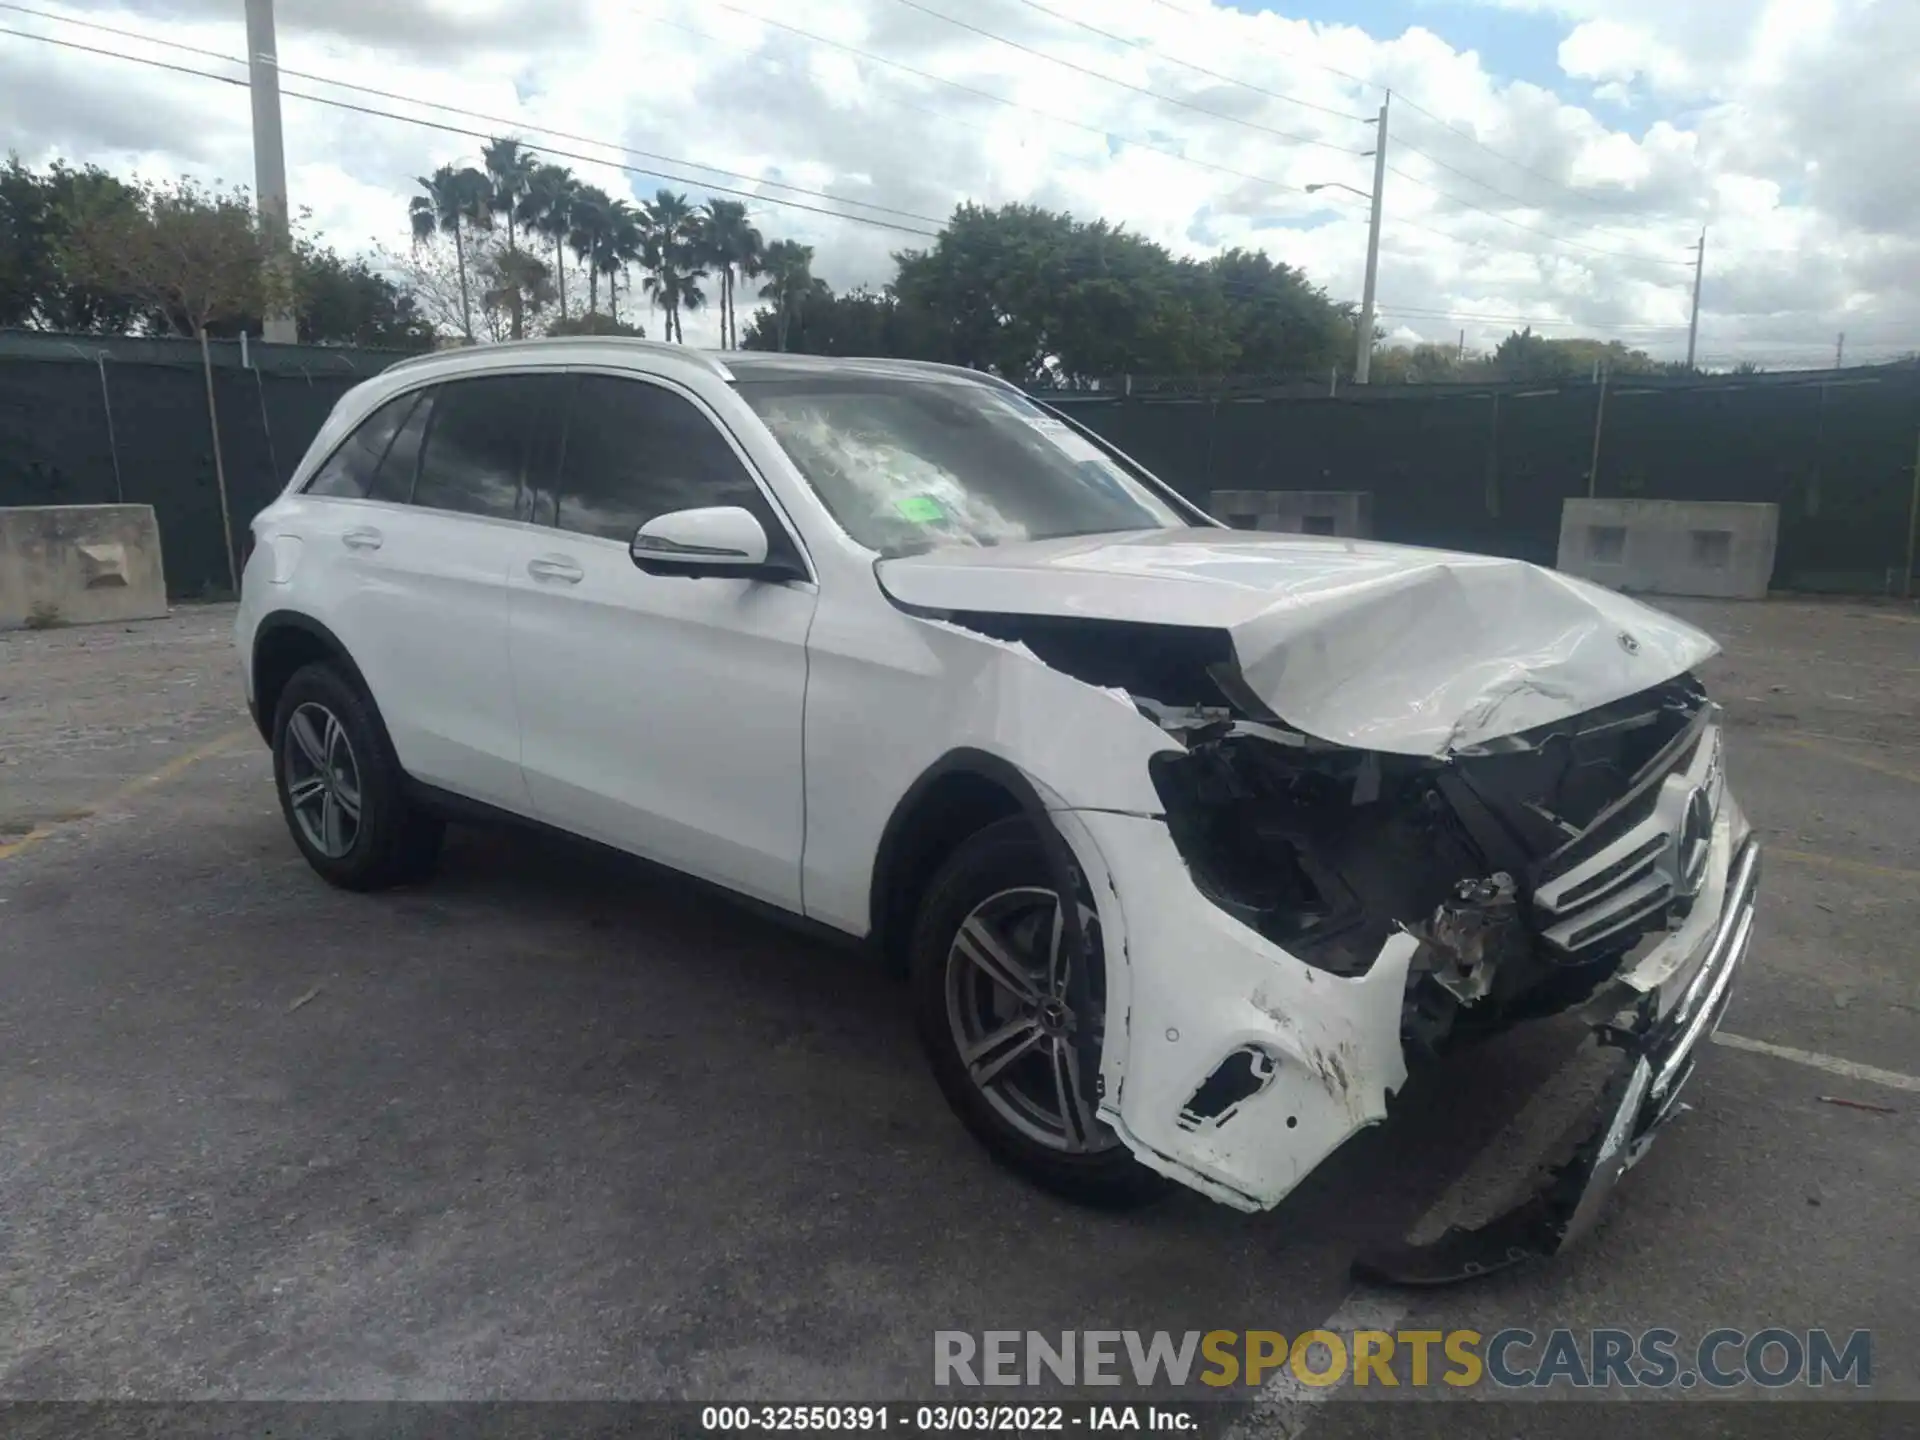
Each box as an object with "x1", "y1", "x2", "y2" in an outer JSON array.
[{"x1": 1046, "y1": 365, "x2": 1920, "y2": 593}]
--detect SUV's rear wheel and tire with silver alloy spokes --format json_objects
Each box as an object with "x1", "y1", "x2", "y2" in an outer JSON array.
[{"x1": 273, "y1": 660, "x2": 445, "y2": 891}]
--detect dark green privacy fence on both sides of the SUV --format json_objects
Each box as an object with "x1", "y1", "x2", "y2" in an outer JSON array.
[{"x1": 11, "y1": 334, "x2": 1920, "y2": 597}]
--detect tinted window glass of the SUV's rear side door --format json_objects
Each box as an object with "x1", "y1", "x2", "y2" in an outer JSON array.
[{"x1": 413, "y1": 374, "x2": 564, "y2": 520}]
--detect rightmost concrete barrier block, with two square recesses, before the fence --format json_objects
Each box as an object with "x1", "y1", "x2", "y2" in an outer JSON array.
[{"x1": 1559, "y1": 499, "x2": 1780, "y2": 599}]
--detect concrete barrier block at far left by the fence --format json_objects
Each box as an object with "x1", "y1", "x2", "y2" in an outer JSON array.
[{"x1": 0, "y1": 505, "x2": 167, "y2": 630}]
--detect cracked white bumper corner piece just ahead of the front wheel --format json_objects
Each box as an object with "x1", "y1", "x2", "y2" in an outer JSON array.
[{"x1": 1054, "y1": 810, "x2": 1417, "y2": 1210}]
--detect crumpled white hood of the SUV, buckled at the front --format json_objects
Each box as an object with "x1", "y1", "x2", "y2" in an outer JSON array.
[{"x1": 876, "y1": 530, "x2": 1718, "y2": 756}]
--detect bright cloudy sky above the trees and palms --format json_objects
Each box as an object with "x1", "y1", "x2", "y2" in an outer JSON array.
[{"x1": 0, "y1": 0, "x2": 1920, "y2": 369}]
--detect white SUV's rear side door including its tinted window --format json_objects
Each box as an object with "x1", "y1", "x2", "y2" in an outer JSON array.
[{"x1": 295, "y1": 372, "x2": 564, "y2": 812}]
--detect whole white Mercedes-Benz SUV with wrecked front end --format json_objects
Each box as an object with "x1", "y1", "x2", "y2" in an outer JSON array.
[{"x1": 236, "y1": 340, "x2": 1759, "y2": 1277}]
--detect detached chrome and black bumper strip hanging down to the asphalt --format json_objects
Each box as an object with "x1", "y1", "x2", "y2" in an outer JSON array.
[{"x1": 1354, "y1": 839, "x2": 1761, "y2": 1284}]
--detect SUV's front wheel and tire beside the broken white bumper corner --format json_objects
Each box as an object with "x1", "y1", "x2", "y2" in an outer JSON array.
[{"x1": 908, "y1": 816, "x2": 1165, "y2": 1208}]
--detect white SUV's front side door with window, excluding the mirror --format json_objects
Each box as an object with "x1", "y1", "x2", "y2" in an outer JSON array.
[{"x1": 509, "y1": 371, "x2": 818, "y2": 910}]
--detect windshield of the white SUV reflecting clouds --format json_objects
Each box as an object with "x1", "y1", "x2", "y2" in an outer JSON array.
[{"x1": 737, "y1": 374, "x2": 1188, "y2": 555}]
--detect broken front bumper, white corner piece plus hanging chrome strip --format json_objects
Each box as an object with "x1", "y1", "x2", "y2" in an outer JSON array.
[{"x1": 1054, "y1": 801, "x2": 1759, "y2": 1284}]
